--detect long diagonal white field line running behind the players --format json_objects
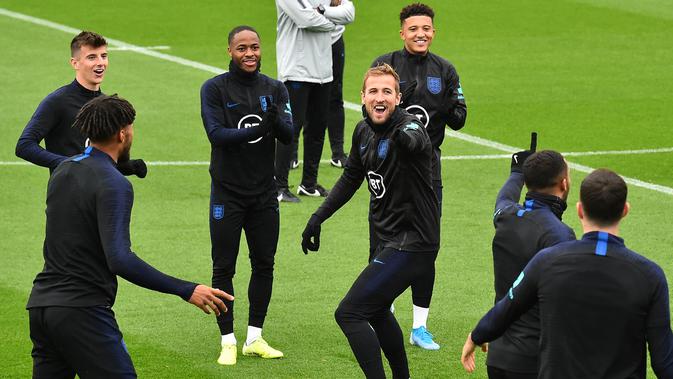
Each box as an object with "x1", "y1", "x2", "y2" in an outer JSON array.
[{"x1": 0, "y1": 8, "x2": 673, "y2": 195}]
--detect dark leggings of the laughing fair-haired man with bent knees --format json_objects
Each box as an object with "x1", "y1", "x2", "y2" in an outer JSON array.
[{"x1": 334, "y1": 248, "x2": 437, "y2": 379}]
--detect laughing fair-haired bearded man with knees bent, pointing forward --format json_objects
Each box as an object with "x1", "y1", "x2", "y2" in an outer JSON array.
[{"x1": 302, "y1": 64, "x2": 439, "y2": 378}]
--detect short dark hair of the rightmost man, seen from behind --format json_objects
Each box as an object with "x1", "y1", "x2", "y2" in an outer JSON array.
[{"x1": 580, "y1": 168, "x2": 628, "y2": 226}]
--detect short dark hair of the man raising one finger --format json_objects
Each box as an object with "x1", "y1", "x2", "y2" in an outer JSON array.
[{"x1": 523, "y1": 150, "x2": 568, "y2": 191}]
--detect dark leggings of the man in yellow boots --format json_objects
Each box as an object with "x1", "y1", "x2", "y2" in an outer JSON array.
[{"x1": 210, "y1": 183, "x2": 280, "y2": 335}]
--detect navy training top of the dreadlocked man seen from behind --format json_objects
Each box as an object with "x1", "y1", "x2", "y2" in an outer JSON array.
[{"x1": 27, "y1": 147, "x2": 196, "y2": 308}]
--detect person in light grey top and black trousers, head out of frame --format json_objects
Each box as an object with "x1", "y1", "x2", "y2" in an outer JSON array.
[{"x1": 276, "y1": 0, "x2": 355, "y2": 203}]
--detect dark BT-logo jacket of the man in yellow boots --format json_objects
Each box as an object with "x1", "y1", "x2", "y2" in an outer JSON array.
[{"x1": 201, "y1": 63, "x2": 292, "y2": 195}]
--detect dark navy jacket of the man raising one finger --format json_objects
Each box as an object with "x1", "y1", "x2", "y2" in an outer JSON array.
[{"x1": 486, "y1": 172, "x2": 575, "y2": 373}]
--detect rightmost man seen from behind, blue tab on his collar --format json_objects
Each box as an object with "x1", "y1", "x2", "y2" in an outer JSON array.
[{"x1": 461, "y1": 169, "x2": 673, "y2": 379}]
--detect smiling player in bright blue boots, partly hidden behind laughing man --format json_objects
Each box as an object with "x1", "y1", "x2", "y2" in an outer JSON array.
[{"x1": 369, "y1": 3, "x2": 467, "y2": 350}]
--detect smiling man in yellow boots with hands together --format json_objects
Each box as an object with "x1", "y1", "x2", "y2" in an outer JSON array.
[{"x1": 201, "y1": 25, "x2": 292, "y2": 365}]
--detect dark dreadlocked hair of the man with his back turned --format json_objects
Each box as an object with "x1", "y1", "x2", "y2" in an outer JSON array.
[{"x1": 72, "y1": 94, "x2": 136, "y2": 142}]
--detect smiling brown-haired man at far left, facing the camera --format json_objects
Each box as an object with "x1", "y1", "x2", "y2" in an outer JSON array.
[{"x1": 16, "y1": 31, "x2": 147, "y2": 178}]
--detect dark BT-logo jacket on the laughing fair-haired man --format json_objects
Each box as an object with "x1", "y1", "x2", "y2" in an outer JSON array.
[{"x1": 315, "y1": 107, "x2": 439, "y2": 252}]
